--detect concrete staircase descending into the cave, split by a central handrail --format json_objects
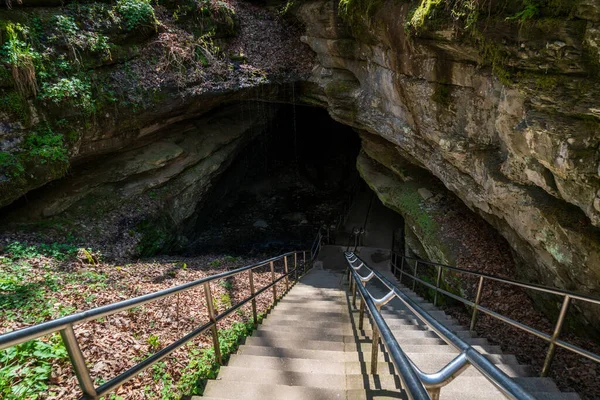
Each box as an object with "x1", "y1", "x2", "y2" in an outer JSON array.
[{"x1": 195, "y1": 246, "x2": 579, "y2": 400}]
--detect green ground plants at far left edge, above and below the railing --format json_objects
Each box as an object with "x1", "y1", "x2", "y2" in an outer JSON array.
[{"x1": 0, "y1": 242, "x2": 106, "y2": 400}]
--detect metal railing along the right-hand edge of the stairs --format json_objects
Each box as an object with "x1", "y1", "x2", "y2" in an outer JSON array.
[{"x1": 391, "y1": 252, "x2": 600, "y2": 377}]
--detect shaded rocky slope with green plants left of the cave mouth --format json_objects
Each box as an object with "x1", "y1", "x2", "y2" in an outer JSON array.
[{"x1": 0, "y1": 0, "x2": 313, "y2": 256}]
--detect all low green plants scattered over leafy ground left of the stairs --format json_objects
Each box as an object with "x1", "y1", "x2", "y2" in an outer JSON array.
[{"x1": 0, "y1": 242, "x2": 263, "y2": 400}]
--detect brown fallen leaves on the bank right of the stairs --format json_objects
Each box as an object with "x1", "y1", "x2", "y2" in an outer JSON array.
[{"x1": 432, "y1": 198, "x2": 600, "y2": 399}]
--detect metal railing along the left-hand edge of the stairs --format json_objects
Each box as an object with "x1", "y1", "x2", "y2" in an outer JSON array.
[{"x1": 0, "y1": 248, "x2": 320, "y2": 399}]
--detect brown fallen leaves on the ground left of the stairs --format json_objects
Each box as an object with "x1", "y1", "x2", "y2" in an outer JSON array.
[{"x1": 0, "y1": 256, "x2": 293, "y2": 399}]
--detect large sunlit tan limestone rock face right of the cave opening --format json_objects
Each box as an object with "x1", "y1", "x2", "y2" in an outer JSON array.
[{"x1": 298, "y1": 0, "x2": 600, "y2": 316}]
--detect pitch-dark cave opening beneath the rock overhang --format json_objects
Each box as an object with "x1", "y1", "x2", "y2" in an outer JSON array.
[{"x1": 189, "y1": 103, "x2": 361, "y2": 254}]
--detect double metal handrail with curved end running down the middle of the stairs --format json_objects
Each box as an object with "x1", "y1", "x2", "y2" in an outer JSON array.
[{"x1": 346, "y1": 252, "x2": 534, "y2": 400}]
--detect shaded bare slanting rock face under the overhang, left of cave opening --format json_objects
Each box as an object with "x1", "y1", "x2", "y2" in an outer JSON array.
[{"x1": 4, "y1": 104, "x2": 269, "y2": 257}]
